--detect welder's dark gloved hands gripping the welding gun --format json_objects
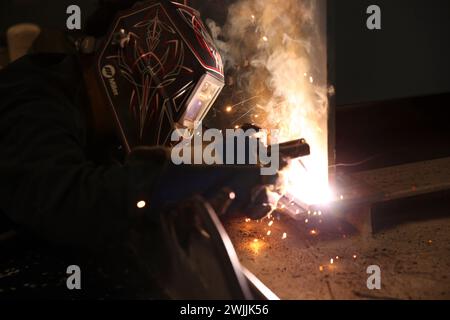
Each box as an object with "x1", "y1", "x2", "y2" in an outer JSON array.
[{"x1": 127, "y1": 147, "x2": 277, "y2": 219}]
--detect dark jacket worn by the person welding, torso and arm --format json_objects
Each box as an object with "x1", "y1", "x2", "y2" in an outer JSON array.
[{"x1": 0, "y1": 55, "x2": 165, "y2": 248}]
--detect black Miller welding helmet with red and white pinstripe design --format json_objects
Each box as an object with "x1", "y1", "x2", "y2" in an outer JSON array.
[{"x1": 95, "y1": 0, "x2": 224, "y2": 151}]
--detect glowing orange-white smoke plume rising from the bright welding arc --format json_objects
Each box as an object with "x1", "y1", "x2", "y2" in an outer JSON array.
[{"x1": 208, "y1": 0, "x2": 328, "y2": 204}]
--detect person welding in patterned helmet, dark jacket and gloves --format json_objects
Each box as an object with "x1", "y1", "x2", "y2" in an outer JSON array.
[{"x1": 0, "y1": 1, "x2": 278, "y2": 298}]
